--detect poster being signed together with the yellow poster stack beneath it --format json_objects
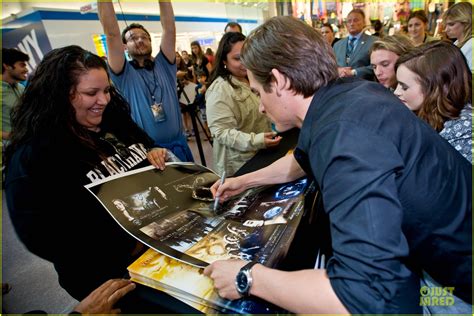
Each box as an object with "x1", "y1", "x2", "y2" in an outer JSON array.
[{"x1": 86, "y1": 163, "x2": 310, "y2": 313}]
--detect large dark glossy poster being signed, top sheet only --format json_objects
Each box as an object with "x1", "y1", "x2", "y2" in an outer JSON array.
[{"x1": 86, "y1": 163, "x2": 307, "y2": 267}]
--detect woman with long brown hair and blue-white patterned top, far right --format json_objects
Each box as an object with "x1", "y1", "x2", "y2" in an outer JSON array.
[{"x1": 395, "y1": 41, "x2": 473, "y2": 163}]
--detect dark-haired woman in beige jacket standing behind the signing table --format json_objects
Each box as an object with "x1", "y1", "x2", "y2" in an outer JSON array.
[{"x1": 206, "y1": 33, "x2": 281, "y2": 175}]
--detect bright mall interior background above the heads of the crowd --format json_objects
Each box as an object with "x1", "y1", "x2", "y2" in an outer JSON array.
[{"x1": 1, "y1": 0, "x2": 457, "y2": 74}]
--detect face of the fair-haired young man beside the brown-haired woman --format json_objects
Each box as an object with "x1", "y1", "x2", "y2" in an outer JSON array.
[{"x1": 370, "y1": 49, "x2": 399, "y2": 88}]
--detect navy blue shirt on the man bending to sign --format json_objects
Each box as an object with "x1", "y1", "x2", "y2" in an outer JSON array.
[{"x1": 295, "y1": 79, "x2": 472, "y2": 314}]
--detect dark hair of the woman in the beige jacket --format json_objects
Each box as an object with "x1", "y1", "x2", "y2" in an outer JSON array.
[{"x1": 208, "y1": 32, "x2": 245, "y2": 89}]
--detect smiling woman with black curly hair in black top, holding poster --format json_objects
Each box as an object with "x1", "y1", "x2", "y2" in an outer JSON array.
[{"x1": 5, "y1": 46, "x2": 166, "y2": 300}]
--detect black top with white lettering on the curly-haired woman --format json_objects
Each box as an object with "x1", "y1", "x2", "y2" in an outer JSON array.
[{"x1": 6, "y1": 123, "x2": 154, "y2": 300}]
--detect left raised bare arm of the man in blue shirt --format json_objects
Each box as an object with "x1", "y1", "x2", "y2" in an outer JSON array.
[{"x1": 97, "y1": 0, "x2": 126, "y2": 74}]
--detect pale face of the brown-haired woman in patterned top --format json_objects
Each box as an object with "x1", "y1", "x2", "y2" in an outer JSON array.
[{"x1": 395, "y1": 65, "x2": 425, "y2": 111}]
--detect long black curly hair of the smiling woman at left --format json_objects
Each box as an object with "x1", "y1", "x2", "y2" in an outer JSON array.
[{"x1": 6, "y1": 45, "x2": 150, "y2": 163}]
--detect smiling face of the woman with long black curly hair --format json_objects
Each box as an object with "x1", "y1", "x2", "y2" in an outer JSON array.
[{"x1": 70, "y1": 68, "x2": 110, "y2": 132}]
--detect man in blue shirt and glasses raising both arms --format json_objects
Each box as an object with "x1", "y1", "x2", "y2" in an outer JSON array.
[{"x1": 97, "y1": 1, "x2": 193, "y2": 161}]
